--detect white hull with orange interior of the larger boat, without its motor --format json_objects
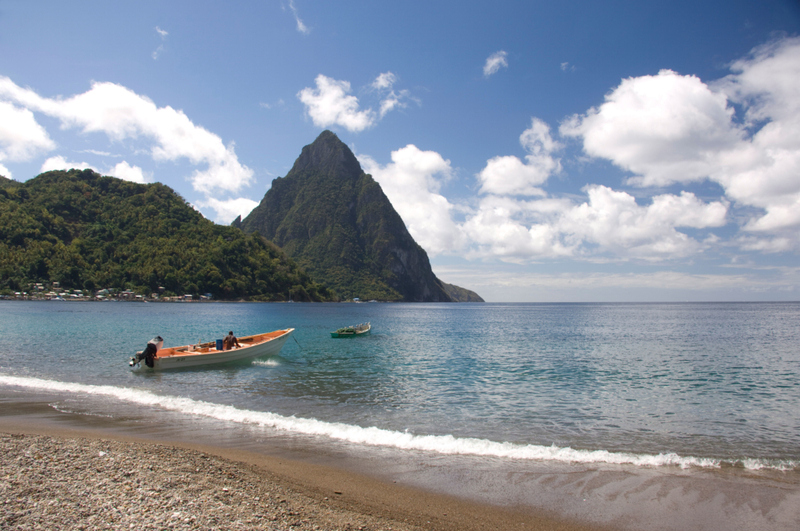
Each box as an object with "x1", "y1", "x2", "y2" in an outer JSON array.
[{"x1": 141, "y1": 328, "x2": 294, "y2": 371}]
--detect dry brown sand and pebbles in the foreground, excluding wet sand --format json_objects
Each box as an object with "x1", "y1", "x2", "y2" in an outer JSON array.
[{"x1": 0, "y1": 416, "x2": 608, "y2": 531}]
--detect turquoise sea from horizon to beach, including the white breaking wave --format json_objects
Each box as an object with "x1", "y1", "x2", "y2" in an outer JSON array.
[{"x1": 0, "y1": 301, "x2": 800, "y2": 470}]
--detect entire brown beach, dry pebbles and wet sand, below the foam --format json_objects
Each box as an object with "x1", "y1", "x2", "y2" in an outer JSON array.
[{"x1": 0, "y1": 402, "x2": 800, "y2": 531}]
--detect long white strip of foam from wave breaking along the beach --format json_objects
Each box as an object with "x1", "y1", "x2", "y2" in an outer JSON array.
[{"x1": 0, "y1": 375, "x2": 800, "y2": 470}]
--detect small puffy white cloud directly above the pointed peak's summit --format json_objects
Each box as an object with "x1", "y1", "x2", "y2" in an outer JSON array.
[{"x1": 297, "y1": 74, "x2": 375, "y2": 132}]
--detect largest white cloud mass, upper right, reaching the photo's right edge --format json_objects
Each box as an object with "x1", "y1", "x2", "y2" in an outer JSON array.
[{"x1": 561, "y1": 38, "x2": 800, "y2": 250}]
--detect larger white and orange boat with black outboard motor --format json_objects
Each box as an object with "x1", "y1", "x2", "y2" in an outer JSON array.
[{"x1": 129, "y1": 328, "x2": 294, "y2": 371}]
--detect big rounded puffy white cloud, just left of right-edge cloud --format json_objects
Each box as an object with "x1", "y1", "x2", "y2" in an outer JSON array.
[{"x1": 561, "y1": 70, "x2": 742, "y2": 186}]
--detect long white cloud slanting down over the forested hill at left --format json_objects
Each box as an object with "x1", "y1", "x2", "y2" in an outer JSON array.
[{"x1": 0, "y1": 77, "x2": 253, "y2": 194}]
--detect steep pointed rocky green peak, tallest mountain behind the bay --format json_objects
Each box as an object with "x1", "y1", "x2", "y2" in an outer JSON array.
[{"x1": 241, "y1": 131, "x2": 478, "y2": 302}]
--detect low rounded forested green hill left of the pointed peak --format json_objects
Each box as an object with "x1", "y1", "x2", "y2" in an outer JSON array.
[{"x1": 0, "y1": 170, "x2": 333, "y2": 301}]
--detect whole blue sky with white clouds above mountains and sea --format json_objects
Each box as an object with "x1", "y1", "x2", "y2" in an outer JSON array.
[{"x1": 0, "y1": 0, "x2": 800, "y2": 302}]
